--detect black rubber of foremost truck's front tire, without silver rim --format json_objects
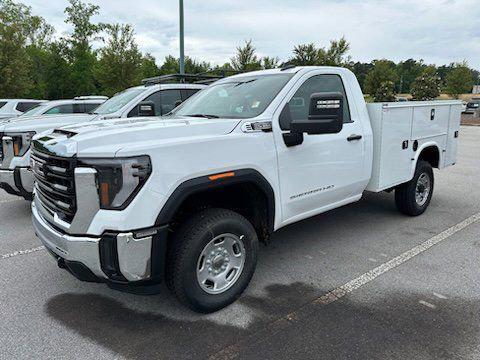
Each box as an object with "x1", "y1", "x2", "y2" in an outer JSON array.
[{"x1": 166, "y1": 209, "x2": 258, "y2": 313}]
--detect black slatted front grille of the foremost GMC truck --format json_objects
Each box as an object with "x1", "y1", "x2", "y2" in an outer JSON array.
[{"x1": 31, "y1": 150, "x2": 77, "y2": 222}]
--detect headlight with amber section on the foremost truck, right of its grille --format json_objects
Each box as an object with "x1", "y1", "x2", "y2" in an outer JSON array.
[{"x1": 79, "y1": 156, "x2": 152, "y2": 210}]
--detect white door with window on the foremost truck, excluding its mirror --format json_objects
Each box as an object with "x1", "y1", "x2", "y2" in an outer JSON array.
[{"x1": 275, "y1": 72, "x2": 365, "y2": 225}]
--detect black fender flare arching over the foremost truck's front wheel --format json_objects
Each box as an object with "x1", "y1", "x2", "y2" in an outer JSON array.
[{"x1": 156, "y1": 169, "x2": 275, "y2": 232}]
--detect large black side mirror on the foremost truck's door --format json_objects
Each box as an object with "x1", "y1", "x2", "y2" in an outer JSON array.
[{"x1": 290, "y1": 93, "x2": 344, "y2": 135}]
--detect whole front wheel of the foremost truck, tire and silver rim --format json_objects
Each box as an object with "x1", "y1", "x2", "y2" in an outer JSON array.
[{"x1": 167, "y1": 209, "x2": 258, "y2": 313}]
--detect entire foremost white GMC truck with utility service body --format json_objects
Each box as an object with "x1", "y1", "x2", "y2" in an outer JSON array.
[{"x1": 31, "y1": 67, "x2": 461, "y2": 312}]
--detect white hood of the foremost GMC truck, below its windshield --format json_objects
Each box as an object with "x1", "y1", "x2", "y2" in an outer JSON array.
[{"x1": 34, "y1": 117, "x2": 240, "y2": 157}]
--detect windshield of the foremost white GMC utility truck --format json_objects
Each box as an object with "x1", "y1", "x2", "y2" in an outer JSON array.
[{"x1": 172, "y1": 74, "x2": 293, "y2": 119}]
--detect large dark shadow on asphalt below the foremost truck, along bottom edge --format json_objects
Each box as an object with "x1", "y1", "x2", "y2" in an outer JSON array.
[{"x1": 45, "y1": 283, "x2": 480, "y2": 359}]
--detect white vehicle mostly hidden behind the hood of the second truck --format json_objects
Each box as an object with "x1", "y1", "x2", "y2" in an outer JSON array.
[{"x1": 20, "y1": 96, "x2": 108, "y2": 119}]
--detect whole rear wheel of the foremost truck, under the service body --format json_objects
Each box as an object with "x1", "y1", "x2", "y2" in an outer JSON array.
[{"x1": 395, "y1": 160, "x2": 434, "y2": 216}]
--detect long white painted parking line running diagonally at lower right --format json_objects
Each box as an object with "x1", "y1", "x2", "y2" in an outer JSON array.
[{"x1": 214, "y1": 213, "x2": 480, "y2": 359}]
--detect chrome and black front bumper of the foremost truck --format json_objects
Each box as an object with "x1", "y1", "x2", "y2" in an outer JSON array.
[{"x1": 32, "y1": 201, "x2": 167, "y2": 290}]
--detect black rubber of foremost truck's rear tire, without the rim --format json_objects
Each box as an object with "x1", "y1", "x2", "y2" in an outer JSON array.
[{"x1": 395, "y1": 160, "x2": 434, "y2": 216}]
